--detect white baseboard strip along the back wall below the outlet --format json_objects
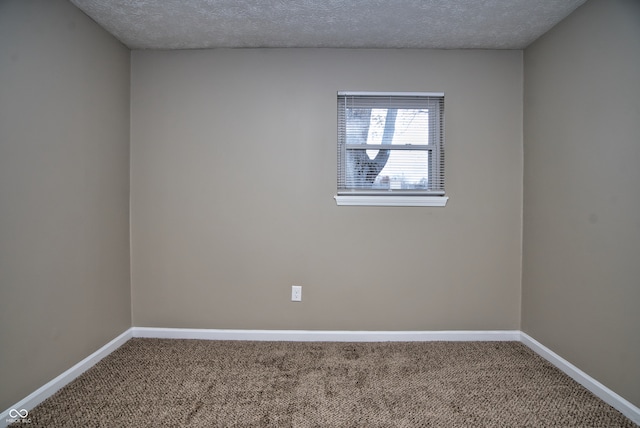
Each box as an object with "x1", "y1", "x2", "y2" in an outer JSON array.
[{"x1": 132, "y1": 327, "x2": 520, "y2": 342}]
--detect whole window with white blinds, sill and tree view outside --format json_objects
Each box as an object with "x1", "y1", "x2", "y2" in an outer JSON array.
[{"x1": 335, "y1": 92, "x2": 448, "y2": 206}]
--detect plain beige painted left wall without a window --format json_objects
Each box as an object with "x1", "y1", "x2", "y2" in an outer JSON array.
[{"x1": 0, "y1": 0, "x2": 131, "y2": 409}]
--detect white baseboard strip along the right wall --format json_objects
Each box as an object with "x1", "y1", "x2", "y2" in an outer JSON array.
[{"x1": 520, "y1": 332, "x2": 640, "y2": 425}]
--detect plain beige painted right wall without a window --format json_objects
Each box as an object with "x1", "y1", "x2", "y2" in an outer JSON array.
[{"x1": 522, "y1": 0, "x2": 640, "y2": 406}]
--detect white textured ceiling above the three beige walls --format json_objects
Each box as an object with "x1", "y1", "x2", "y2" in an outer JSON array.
[{"x1": 71, "y1": 0, "x2": 585, "y2": 49}]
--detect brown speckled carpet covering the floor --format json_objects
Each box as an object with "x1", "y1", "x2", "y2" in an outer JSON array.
[{"x1": 15, "y1": 339, "x2": 637, "y2": 428}]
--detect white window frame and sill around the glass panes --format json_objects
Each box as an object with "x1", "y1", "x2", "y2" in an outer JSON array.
[{"x1": 334, "y1": 91, "x2": 449, "y2": 207}]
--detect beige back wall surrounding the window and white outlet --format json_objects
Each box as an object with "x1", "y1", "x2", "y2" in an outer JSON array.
[{"x1": 131, "y1": 49, "x2": 522, "y2": 330}]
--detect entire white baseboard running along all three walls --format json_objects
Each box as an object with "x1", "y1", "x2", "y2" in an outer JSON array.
[{"x1": 0, "y1": 327, "x2": 640, "y2": 428}]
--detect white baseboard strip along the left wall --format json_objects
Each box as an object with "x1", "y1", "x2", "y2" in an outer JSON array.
[{"x1": 0, "y1": 329, "x2": 133, "y2": 428}]
